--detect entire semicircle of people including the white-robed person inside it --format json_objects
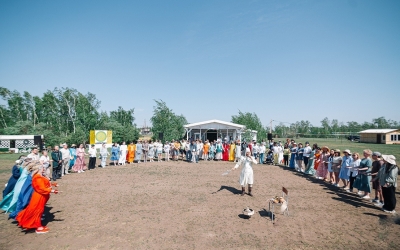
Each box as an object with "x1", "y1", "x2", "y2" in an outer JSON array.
[{"x1": 0, "y1": 138, "x2": 398, "y2": 234}]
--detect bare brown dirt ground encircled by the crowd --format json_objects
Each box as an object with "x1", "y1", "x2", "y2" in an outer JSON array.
[{"x1": 0, "y1": 161, "x2": 400, "y2": 249}]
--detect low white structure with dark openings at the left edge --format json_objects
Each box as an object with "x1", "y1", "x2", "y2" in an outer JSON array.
[{"x1": 0, "y1": 135, "x2": 43, "y2": 151}]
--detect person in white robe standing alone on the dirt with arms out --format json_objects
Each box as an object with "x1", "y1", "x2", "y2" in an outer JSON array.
[{"x1": 232, "y1": 148, "x2": 257, "y2": 196}]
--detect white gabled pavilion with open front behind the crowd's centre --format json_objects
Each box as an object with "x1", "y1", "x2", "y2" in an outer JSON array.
[{"x1": 183, "y1": 120, "x2": 257, "y2": 141}]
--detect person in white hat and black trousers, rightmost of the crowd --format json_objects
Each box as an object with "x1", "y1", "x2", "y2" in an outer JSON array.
[{"x1": 376, "y1": 155, "x2": 399, "y2": 213}]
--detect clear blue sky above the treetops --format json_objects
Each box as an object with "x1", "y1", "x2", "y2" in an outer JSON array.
[{"x1": 0, "y1": 0, "x2": 400, "y2": 126}]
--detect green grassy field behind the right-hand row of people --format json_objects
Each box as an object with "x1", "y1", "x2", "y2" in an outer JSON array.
[{"x1": 274, "y1": 138, "x2": 400, "y2": 159}]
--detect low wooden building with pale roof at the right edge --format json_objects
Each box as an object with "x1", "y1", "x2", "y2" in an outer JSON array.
[{"x1": 360, "y1": 129, "x2": 400, "y2": 144}]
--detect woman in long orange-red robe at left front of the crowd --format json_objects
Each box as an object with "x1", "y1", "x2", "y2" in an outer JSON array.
[{"x1": 15, "y1": 162, "x2": 58, "y2": 234}]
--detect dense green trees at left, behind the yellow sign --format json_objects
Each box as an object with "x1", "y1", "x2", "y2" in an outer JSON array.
[{"x1": 0, "y1": 87, "x2": 139, "y2": 146}]
